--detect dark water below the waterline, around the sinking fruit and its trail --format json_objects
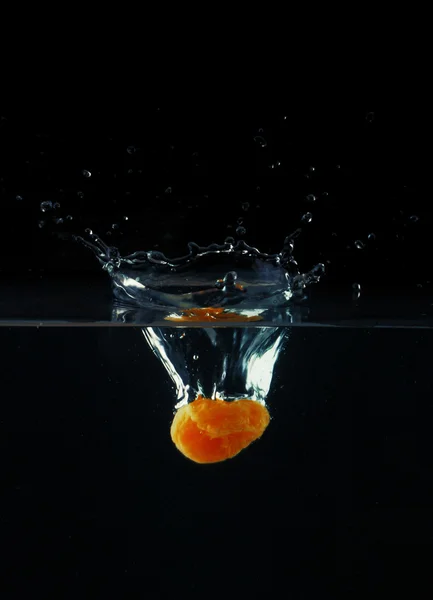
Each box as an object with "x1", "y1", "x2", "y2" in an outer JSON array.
[{"x1": 0, "y1": 326, "x2": 433, "y2": 598}]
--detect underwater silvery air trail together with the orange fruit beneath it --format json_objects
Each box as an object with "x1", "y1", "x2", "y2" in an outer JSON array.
[{"x1": 142, "y1": 327, "x2": 288, "y2": 464}]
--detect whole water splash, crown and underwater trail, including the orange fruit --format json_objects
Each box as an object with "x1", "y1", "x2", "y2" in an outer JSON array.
[{"x1": 76, "y1": 229, "x2": 324, "y2": 464}]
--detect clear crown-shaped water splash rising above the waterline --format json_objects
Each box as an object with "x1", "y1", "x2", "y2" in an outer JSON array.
[{"x1": 75, "y1": 229, "x2": 324, "y2": 323}]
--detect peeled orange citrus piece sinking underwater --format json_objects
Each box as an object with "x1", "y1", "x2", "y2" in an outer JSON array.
[{"x1": 171, "y1": 395, "x2": 270, "y2": 463}]
